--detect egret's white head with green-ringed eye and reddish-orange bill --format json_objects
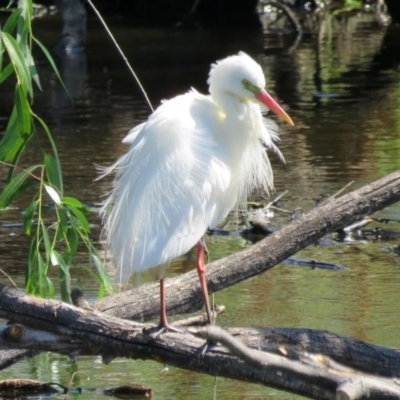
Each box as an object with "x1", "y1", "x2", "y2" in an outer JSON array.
[{"x1": 208, "y1": 51, "x2": 293, "y2": 125}]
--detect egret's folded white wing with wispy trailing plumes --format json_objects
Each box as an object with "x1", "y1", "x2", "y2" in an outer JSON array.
[{"x1": 103, "y1": 92, "x2": 230, "y2": 281}]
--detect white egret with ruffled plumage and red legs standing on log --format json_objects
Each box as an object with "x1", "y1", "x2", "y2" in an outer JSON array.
[{"x1": 102, "y1": 52, "x2": 293, "y2": 329}]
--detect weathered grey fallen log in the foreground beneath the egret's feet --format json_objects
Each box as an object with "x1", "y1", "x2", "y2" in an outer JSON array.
[{"x1": 0, "y1": 285, "x2": 400, "y2": 399}]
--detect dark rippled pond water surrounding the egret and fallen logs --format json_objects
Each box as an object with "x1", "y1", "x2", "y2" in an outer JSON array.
[{"x1": 0, "y1": 7, "x2": 400, "y2": 399}]
